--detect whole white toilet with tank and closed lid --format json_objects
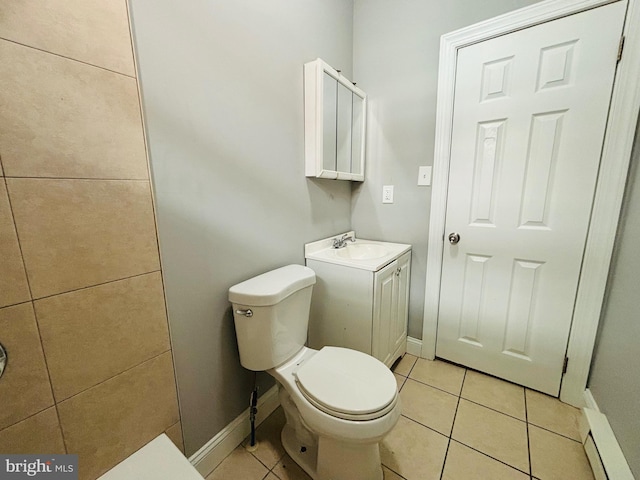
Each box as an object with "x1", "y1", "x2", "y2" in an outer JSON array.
[{"x1": 229, "y1": 265, "x2": 401, "y2": 480}]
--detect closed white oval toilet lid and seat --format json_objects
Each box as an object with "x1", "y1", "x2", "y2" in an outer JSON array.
[{"x1": 294, "y1": 347, "x2": 398, "y2": 420}]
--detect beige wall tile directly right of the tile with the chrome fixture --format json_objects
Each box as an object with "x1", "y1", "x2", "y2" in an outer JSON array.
[{"x1": 34, "y1": 272, "x2": 170, "y2": 401}]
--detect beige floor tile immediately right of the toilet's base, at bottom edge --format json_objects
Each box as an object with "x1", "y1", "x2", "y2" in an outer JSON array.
[{"x1": 380, "y1": 417, "x2": 449, "y2": 480}]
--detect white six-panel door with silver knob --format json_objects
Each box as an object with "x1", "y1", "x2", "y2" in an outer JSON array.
[{"x1": 436, "y1": 2, "x2": 626, "y2": 395}]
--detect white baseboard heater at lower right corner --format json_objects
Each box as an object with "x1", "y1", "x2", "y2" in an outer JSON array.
[{"x1": 580, "y1": 408, "x2": 635, "y2": 480}]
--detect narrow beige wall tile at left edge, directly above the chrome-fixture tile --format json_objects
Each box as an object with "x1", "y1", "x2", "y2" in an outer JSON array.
[{"x1": 0, "y1": 179, "x2": 31, "y2": 307}]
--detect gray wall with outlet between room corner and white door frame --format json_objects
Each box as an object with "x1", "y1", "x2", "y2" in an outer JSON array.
[{"x1": 352, "y1": 0, "x2": 536, "y2": 338}]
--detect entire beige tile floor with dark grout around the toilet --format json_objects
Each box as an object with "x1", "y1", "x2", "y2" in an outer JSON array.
[{"x1": 207, "y1": 354, "x2": 593, "y2": 480}]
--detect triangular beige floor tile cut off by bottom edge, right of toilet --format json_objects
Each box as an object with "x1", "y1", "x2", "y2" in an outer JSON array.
[{"x1": 442, "y1": 440, "x2": 529, "y2": 480}]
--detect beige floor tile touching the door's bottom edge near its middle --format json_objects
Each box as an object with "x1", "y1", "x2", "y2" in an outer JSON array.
[{"x1": 460, "y1": 370, "x2": 527, "y2": 420}]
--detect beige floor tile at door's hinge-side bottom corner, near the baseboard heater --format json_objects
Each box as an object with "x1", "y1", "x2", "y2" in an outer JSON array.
[{"x1": 526, "y1": 389, "x2": 582, "y2": 441}]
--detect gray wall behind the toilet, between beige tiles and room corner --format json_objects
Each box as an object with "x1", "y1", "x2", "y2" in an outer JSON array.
[{"x1": 130, "y1": 0, "x2": 353, "y2": 455}]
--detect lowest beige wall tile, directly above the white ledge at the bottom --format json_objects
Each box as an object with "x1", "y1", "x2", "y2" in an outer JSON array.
[{"x1": 58, "y1": 352, "x2": 179, "y2": 479}]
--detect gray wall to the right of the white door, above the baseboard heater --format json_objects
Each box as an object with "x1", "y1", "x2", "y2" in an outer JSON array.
[{"x1": 588, "y1": 117, "x2": 640, "y2": 478}]
